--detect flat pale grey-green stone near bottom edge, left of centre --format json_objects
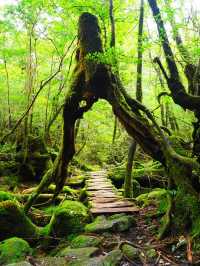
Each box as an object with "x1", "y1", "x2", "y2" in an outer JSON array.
[{"x1": 56, "y1": 247, "x2": 98, "y2": 260}]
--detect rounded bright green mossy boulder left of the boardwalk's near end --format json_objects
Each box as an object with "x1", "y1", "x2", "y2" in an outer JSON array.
[{"x1": 47, "y1": 200, "x2": 89, "y2": 237}]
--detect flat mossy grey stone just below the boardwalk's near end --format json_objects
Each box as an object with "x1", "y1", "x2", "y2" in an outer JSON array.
[{"x1": 85, "y1": 213, "x2": 135, "y2": 233}]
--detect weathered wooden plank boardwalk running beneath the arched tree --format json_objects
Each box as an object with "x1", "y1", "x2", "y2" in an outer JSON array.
[{"x1": 86, "y1": 171, "x2": 139, "y2": 214}]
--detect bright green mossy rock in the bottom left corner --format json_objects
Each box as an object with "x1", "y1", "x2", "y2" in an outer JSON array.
[{"x1": 0, "y1": 237, "x2": 32, "y2": 265}]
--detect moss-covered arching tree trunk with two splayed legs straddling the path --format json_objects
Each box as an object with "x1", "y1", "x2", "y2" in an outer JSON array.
[{"x1": 25, "y1": 13, "x2": 199, "y2": 239}]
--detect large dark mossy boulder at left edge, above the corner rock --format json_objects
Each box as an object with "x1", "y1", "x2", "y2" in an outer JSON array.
[{"x1": 0, "y1": 200, "x2": 40, "y2": 240}]
